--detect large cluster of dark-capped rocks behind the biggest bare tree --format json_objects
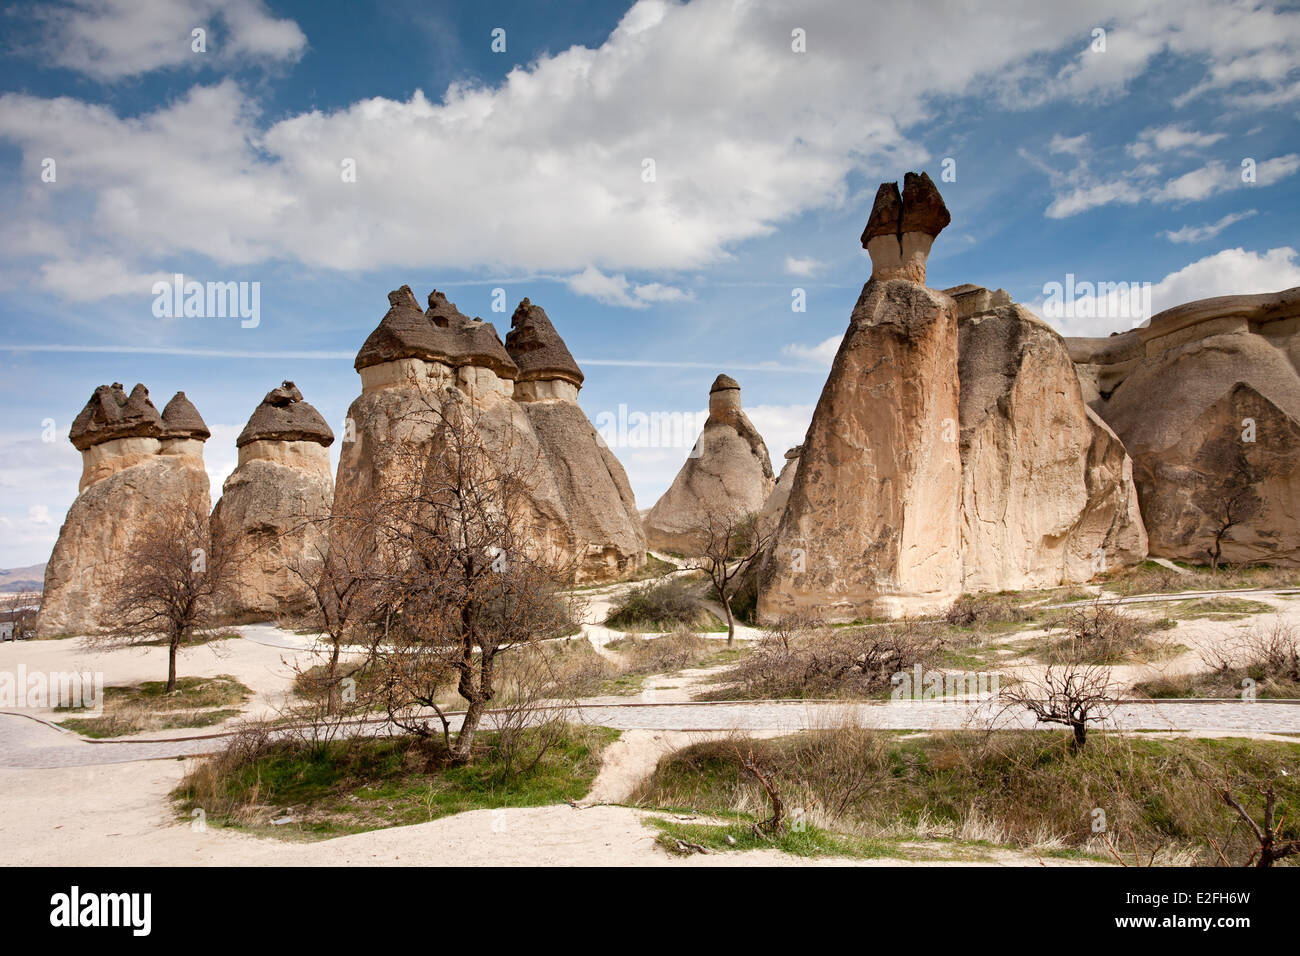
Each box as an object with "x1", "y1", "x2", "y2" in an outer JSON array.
[{"x1": 335, "y1": 286, "x2": 645, "y2": 581}]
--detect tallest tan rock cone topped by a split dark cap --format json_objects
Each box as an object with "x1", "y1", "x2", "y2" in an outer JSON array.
[{"x1": 758, "y1": 176, "x2": 961, "y2": 620}]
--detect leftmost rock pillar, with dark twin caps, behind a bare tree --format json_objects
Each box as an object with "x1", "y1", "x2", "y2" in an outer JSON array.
[{"x1": 36, "y1": 382, "x2": 211, "y2": 637}]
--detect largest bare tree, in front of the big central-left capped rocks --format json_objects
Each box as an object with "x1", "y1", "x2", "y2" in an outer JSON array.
[{"x1": 358, "y1": 389, "x2": 572, "y2": 763}]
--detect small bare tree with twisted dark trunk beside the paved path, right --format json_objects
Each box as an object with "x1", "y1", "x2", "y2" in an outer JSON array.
[{"x1": 1000, "y1": 635, "x2": 1118, "y2": 753}]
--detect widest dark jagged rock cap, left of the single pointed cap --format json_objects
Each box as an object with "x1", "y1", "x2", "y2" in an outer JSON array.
[{"x1": 352, "y1": 285, "x2": 519, "y2": 378}]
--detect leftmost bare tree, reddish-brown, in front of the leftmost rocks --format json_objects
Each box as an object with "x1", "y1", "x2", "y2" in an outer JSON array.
[{"x1": 85, "y1": 501, "x2": 233, "y2": 695}]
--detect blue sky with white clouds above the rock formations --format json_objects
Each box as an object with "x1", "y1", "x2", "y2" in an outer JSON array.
[{"x1": 0, "y1": 0, "x2": 1300, "y2": 567}]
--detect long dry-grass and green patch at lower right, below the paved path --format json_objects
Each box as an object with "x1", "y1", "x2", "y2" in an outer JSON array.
[{"x1": 632, "y1": 728, "x2": 1300, "y2": 864}]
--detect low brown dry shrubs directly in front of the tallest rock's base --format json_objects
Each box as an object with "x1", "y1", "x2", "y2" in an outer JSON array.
[{"x1": 723, "y1": 618, "x2": 944, "y2": 698}]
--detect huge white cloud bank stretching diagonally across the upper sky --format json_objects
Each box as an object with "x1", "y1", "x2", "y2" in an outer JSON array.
[{"x1": 0, "y1": 0, "x2": 1300, "y2": 302}]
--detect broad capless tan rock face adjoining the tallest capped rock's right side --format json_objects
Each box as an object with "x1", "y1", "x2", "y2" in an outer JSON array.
[{"x1": 958, "y1": 300, "x2": 1147, "y2": 592}]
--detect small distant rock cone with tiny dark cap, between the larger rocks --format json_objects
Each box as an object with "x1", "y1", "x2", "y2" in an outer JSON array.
[{"x1": 645, "y1": 375, "x2": 775, "y2": 555}]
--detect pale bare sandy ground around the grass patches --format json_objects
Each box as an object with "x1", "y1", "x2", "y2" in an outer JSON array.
[{"x1": 0, "y1": 572, "x2": 1300, "y2": 866}]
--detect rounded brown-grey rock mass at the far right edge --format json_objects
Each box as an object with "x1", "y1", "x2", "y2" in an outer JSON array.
[{"x1": 1070, "y1": 287, "x2": 1300, "y2": 566}]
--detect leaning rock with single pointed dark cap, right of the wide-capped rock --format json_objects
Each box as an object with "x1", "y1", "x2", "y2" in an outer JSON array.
[{"x1": 506, "y1": 299, "x2": 646, "y2": 581}]
